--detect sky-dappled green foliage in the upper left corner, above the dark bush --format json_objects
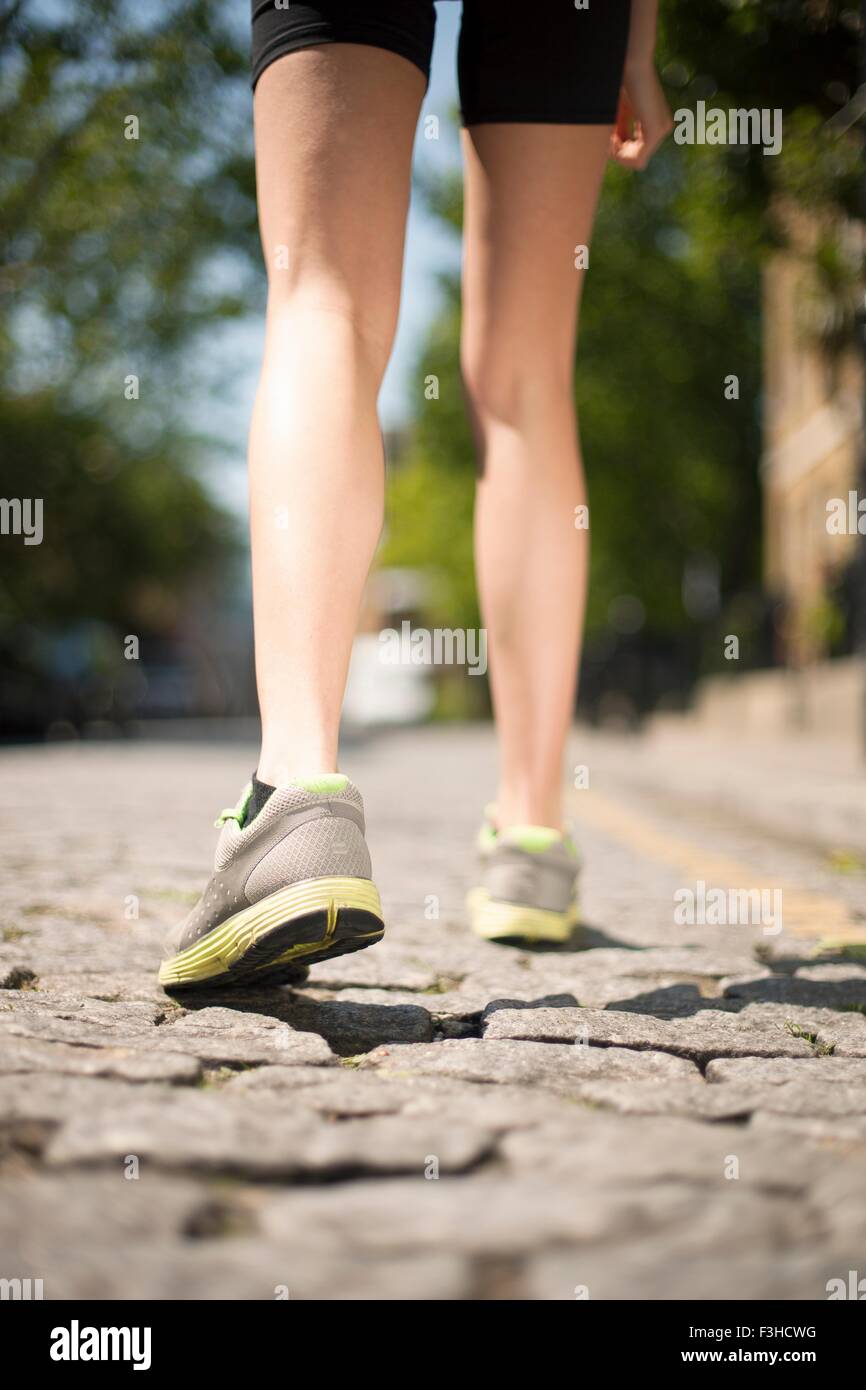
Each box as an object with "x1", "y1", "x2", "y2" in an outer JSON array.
[{"x1": 0, "y1": 0, "x2": 254, "y2": 411}]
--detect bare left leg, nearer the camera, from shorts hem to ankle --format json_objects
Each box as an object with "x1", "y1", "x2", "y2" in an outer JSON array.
[{"x1": 249, "y1": 43, "x2": 424, "y2": 785}]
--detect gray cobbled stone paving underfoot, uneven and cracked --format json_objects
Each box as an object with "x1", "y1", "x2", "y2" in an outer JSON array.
[{"x1": 0, "y1": 727, "x2": 866, "y2": 1300}]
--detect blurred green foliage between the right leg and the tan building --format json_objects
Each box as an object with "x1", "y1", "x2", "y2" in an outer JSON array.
[{"x1": 577, "y1": 149, "x2": 760, "y2": 632}]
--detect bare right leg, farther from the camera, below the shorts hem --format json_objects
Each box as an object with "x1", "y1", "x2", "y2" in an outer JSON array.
[{"x1": 461, "y1": 124, "x2": 610, "y2": 827}]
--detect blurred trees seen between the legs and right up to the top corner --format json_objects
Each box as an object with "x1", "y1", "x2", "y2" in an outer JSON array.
[{"x1": 382, "y1": 0, "x2": 860, "y2": 706}]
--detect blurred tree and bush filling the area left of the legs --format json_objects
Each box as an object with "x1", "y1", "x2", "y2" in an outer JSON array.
[{"x1": 0, "y1": 0, "x2": 261, "y2": 717}]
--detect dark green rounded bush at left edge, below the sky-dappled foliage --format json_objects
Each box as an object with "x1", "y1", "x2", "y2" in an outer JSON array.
[{"x1": 0, "y1": 392, "x2": 234, "y2": 637}]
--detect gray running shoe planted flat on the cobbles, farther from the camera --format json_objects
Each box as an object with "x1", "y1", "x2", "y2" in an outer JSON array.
[{"x1": 467, "y1": 809, "x2": 580, "y2": 942}]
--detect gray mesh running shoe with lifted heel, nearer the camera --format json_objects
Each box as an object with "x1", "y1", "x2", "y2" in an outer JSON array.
[{"x1": 160, "y1": 773, "x2": 385, "y2": 990}]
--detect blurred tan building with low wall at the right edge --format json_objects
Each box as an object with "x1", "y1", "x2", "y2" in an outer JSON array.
[{"x1": 678, "y1": 217, "x2": 866, "y2": 758}]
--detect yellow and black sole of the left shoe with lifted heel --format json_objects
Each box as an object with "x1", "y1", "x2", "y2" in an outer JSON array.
[{"x1": 160, "y1": 878, "x2": 385, "y2": 990}]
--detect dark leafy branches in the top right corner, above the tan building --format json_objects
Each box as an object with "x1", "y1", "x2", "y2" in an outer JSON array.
[{"x1": 659, "y1": 0, "x2": 865, "y2": 350}]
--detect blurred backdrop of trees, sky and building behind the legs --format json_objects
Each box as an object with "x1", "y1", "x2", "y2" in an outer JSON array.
[{"x1": 0, "y1": 0, "x2": 866, "y2": 749}]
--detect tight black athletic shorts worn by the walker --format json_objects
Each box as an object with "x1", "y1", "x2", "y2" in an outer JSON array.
[{"x1": 252, "y1": 0, "x2": 630, "y2": 125}]
